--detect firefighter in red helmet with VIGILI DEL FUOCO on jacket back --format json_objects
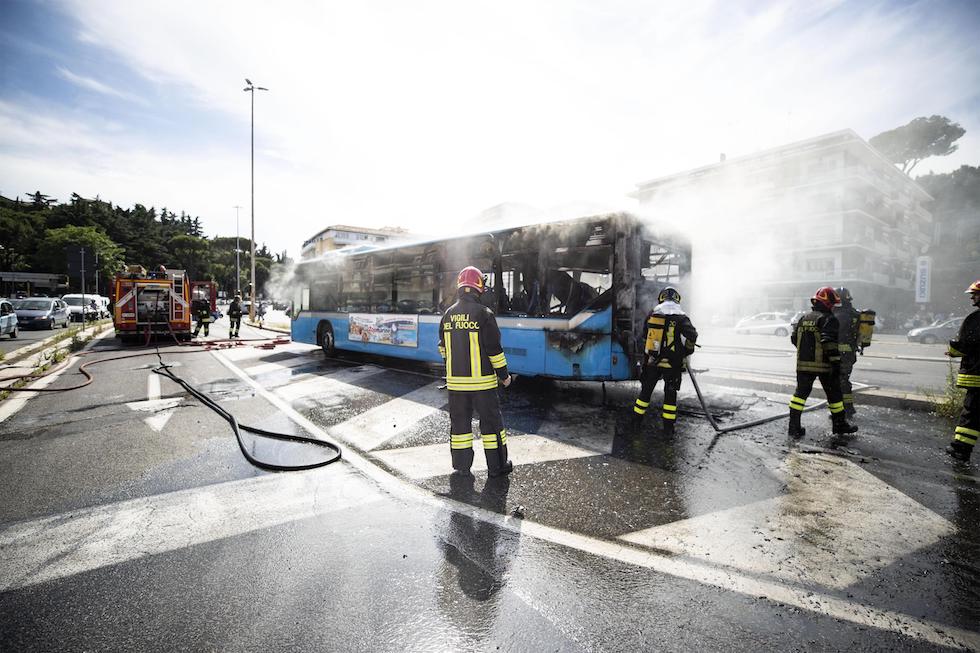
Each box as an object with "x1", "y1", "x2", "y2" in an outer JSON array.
[{"x1": 439, "y1": 266, "x2": 514, "y2": 477}]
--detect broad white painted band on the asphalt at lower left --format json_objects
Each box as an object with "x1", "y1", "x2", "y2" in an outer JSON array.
[{"x1": 0, "y1": 465, "x2": 382, "y2": 592}]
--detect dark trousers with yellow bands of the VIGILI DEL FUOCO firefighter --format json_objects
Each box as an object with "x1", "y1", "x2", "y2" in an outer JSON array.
[{"x1": 449, "y1": 388, "x2": 508, "y2": 476}]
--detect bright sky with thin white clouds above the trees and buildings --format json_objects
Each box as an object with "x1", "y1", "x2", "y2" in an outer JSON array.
[{"x1": 0, "y1": 0, "x2": 980, "y2": 257}]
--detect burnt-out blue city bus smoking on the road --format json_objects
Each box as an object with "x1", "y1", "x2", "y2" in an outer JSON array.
[{"x1": 291, "y1": 213, "x2": 691, "y2": 381}]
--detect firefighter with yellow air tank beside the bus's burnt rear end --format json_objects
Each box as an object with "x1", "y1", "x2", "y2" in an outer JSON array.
[{"x1": 633, "y1": 286, "x2": 698, "y2": 435}]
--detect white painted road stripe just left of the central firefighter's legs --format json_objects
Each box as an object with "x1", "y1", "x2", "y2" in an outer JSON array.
[{"x1": 328, "y1": 381, "x2": 449, "y2": 451}]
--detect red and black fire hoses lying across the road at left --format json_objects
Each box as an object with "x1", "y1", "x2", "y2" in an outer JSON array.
[{"x1": 0, "y1": 323, "x2": 342, "y2": 472}]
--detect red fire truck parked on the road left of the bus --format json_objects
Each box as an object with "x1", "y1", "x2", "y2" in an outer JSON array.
[{"x1": 112, "y1": 265, "x2": 217, "y2": 341}]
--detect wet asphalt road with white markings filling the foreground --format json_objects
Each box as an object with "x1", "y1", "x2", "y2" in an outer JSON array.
[{"x1": 0, "y1": 320, "x2": 980, "y2": 651}]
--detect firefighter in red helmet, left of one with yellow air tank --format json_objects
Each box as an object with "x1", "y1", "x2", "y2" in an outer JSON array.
[{"x1": 789, "y1": 286, "x2": 858, "y2": 437}]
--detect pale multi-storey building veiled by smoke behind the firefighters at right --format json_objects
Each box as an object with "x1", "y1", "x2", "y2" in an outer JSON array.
[{"x1": 631, "y1": 129, "x2": 932, "y2": 318}]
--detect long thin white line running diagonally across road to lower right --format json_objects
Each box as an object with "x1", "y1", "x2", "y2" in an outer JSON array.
[{"x1": 212, "y1": 352, "x2": 980, "y2": 650}]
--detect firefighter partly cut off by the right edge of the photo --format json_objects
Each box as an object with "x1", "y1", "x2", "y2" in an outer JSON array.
[{"x1": 946, "y1": 279, "x2": 980, "y2": 461}]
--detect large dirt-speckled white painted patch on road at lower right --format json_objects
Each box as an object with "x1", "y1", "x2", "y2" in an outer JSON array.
[{"x1": 620, "y1": 453, "x2": 956, "y2": 590}]
